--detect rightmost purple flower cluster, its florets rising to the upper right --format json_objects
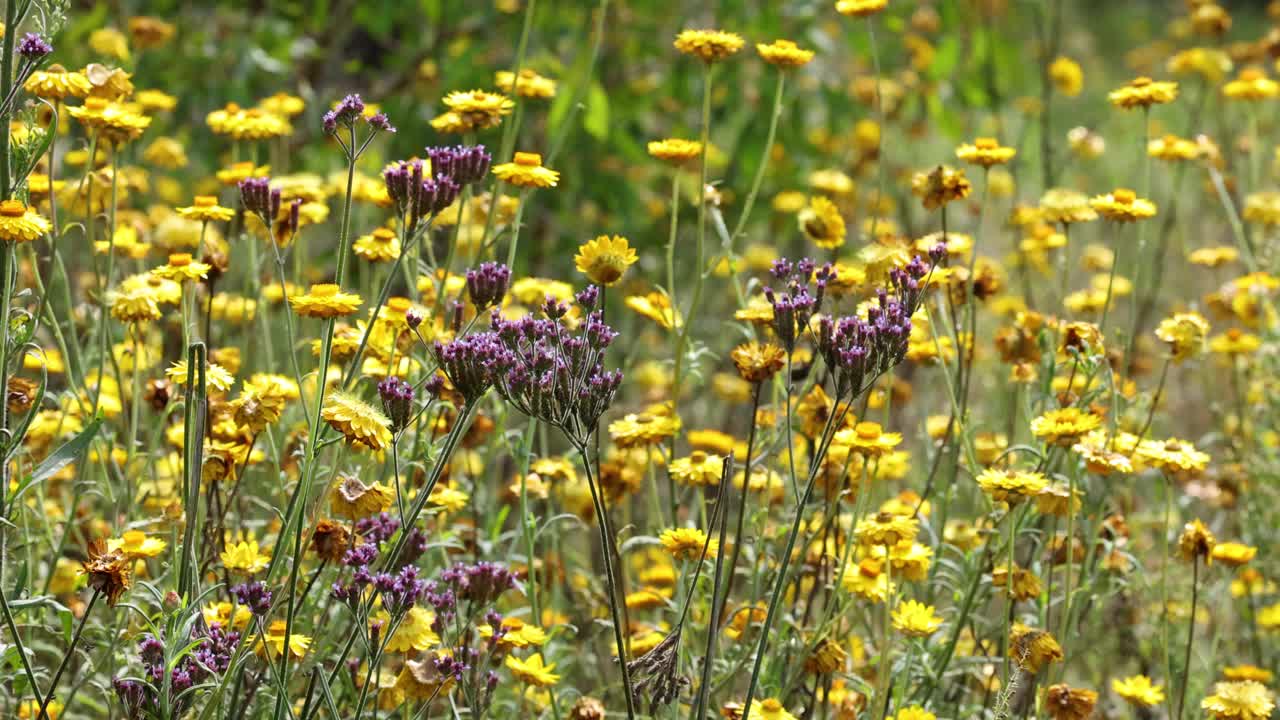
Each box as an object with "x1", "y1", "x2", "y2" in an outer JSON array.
[{"x1": 818, "y1": 252, "x2": 929, "y2": 398}]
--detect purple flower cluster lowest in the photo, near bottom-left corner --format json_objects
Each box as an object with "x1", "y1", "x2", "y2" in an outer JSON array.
[{"x1": 111, "y1": 623, "x2": 241, "y2": 719}]
